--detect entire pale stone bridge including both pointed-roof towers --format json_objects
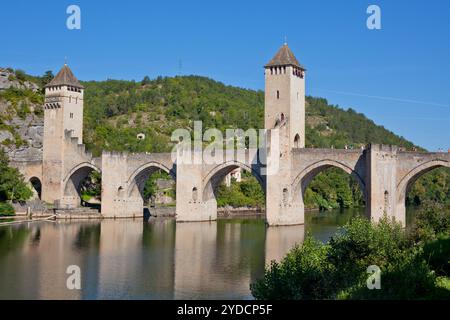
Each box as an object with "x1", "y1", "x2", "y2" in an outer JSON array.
[{"x1": 9, "y1": 44, "x2": 450, "y2": 225}]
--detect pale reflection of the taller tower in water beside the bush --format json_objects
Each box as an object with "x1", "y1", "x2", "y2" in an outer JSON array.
[{"x1": 266, "y1": 224, "x2": 305, "y2": 265}]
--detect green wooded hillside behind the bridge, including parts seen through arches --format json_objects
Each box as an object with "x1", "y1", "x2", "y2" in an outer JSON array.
[{"x1": 0, "y1": 72, "x2": 450, "y2": 209}]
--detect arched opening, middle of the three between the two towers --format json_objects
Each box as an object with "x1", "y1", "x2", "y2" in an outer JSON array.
[{"x1": 128, "y1": 163, "x2": 176, "y2": 217}]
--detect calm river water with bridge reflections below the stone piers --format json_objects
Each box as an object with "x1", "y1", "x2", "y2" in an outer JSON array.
[{"x1": 0, "y1": 209, "x2": 414, "y2": 299}]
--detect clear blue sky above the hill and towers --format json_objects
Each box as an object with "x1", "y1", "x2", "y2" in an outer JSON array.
[{"x1": 0, "y1": 0, "x2": 450, "y2": 150}]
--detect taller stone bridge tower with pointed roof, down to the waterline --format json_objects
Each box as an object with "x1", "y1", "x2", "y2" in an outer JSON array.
[{"x1": 264, "y1": 43, "x2": 306, "y2": 225}]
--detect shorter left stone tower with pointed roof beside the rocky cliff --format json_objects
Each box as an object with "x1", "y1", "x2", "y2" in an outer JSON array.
[{"x1": 42, "y1": 64, "x2": 84, "y2": 203}]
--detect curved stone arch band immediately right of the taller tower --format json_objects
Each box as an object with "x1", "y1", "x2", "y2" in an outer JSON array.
[{"x1": 292, "y1": 159, "x2": 367, "y2": 203}]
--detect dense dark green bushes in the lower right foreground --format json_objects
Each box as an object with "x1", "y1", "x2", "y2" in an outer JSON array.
[{"x1": 251, "y1": 202, "x2": 450, "y2": 299}]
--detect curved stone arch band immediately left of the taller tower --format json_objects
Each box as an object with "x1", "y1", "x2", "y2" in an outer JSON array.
[{"x1": 202, "y1": 160, "x2": 266, "y2": 201}]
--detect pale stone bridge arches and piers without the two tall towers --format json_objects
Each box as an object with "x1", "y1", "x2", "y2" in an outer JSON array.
[{"x1": 16, "y1": 135, "x2": 450, "y2": 225}]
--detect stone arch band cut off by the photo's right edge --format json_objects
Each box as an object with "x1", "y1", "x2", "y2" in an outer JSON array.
[{"x1": 397, "y1": 159, "x2": 450, "y2": 206}]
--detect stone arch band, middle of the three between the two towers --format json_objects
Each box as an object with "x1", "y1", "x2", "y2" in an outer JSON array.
[{"x1": 126, "y1": 161, "x2": 176, "y2": 197}]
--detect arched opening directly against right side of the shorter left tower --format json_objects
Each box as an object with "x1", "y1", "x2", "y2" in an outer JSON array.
[{"x1": 63, "y1": 163, "x2": 102, "y2": 210}]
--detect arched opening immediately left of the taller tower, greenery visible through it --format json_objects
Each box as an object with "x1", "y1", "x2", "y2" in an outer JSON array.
[{"x1": 202, "y1": 161, "x2": 265, "y2": 216}]
